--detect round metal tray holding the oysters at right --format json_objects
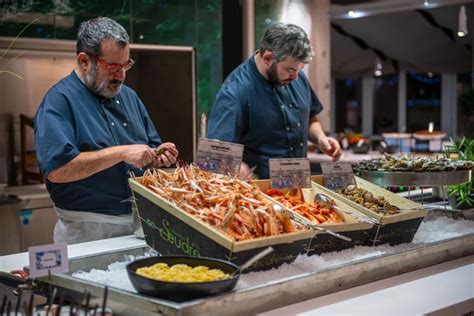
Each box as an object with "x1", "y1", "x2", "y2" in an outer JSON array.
[{"x1": 358, "y1": 170, "x2": 471, "y2": 187}]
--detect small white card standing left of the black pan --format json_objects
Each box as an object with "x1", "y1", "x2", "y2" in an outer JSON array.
[{"x1": 28, "y1": 243, "x2": 69, "y2": 278}]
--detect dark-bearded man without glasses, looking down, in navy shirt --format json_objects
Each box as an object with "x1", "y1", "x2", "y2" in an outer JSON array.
[{"x1": 208, "y1": 24, "x2": 341, "y2": 178}]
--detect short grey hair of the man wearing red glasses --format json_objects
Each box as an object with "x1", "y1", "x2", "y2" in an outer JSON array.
[{"x1": 76, "y1": 17, "x2": 129, "y2": 56}]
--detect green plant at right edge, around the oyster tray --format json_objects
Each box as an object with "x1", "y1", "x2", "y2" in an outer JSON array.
[{"x1": 445, "y1": 137, "x2": 474, "y2": 206}]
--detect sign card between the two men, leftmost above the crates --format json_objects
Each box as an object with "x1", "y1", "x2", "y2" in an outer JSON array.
[{"x1": 196, "y1": 138, "x2": 244, "y2": 176}]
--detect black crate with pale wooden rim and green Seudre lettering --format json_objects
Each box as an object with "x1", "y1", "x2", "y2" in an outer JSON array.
[{"x1": 129, "y1": 178, "x2": 315, "y2": 272}]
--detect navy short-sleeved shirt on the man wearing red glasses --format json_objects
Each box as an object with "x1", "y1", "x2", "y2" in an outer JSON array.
[{"x1": 35, "y1": 71, "x2": 161, "y2": 215}]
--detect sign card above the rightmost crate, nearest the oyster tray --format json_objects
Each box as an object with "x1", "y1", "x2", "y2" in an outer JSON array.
[{"x1": 321, "y1": 162, "x2": 356, "y2": 190}]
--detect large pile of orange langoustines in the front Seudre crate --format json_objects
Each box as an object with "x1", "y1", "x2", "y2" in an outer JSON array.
[{"x1": 140, "y1": 164, "x2": 305, "y2": 241}]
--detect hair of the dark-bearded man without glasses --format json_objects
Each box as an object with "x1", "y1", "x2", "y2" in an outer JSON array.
[{"x1": 260, "y1": 23, "x2": 314, "y2": 64}]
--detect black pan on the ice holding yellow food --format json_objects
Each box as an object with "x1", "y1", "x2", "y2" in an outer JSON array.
[{"x1": 127, "y1": 256, "x2": 240, "y2": 301}]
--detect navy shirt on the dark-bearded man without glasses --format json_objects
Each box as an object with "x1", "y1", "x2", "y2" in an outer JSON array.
[{"x1": 208, "y1": 57, "x2": 322, "y2": 179}]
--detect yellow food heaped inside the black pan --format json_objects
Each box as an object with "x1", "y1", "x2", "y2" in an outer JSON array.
[{"x1": 136, "y1": 263, "x2": 229, "y2": 283}]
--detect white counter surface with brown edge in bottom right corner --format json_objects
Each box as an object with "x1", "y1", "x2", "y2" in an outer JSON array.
[{"x1": 259, "y1": 256, "x2": 474, "y2": 316}]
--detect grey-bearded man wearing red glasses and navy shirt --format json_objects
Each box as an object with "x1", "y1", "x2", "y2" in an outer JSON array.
[{"x1": 35, "y1": 17, "x2": 178, "y2": 243}]
